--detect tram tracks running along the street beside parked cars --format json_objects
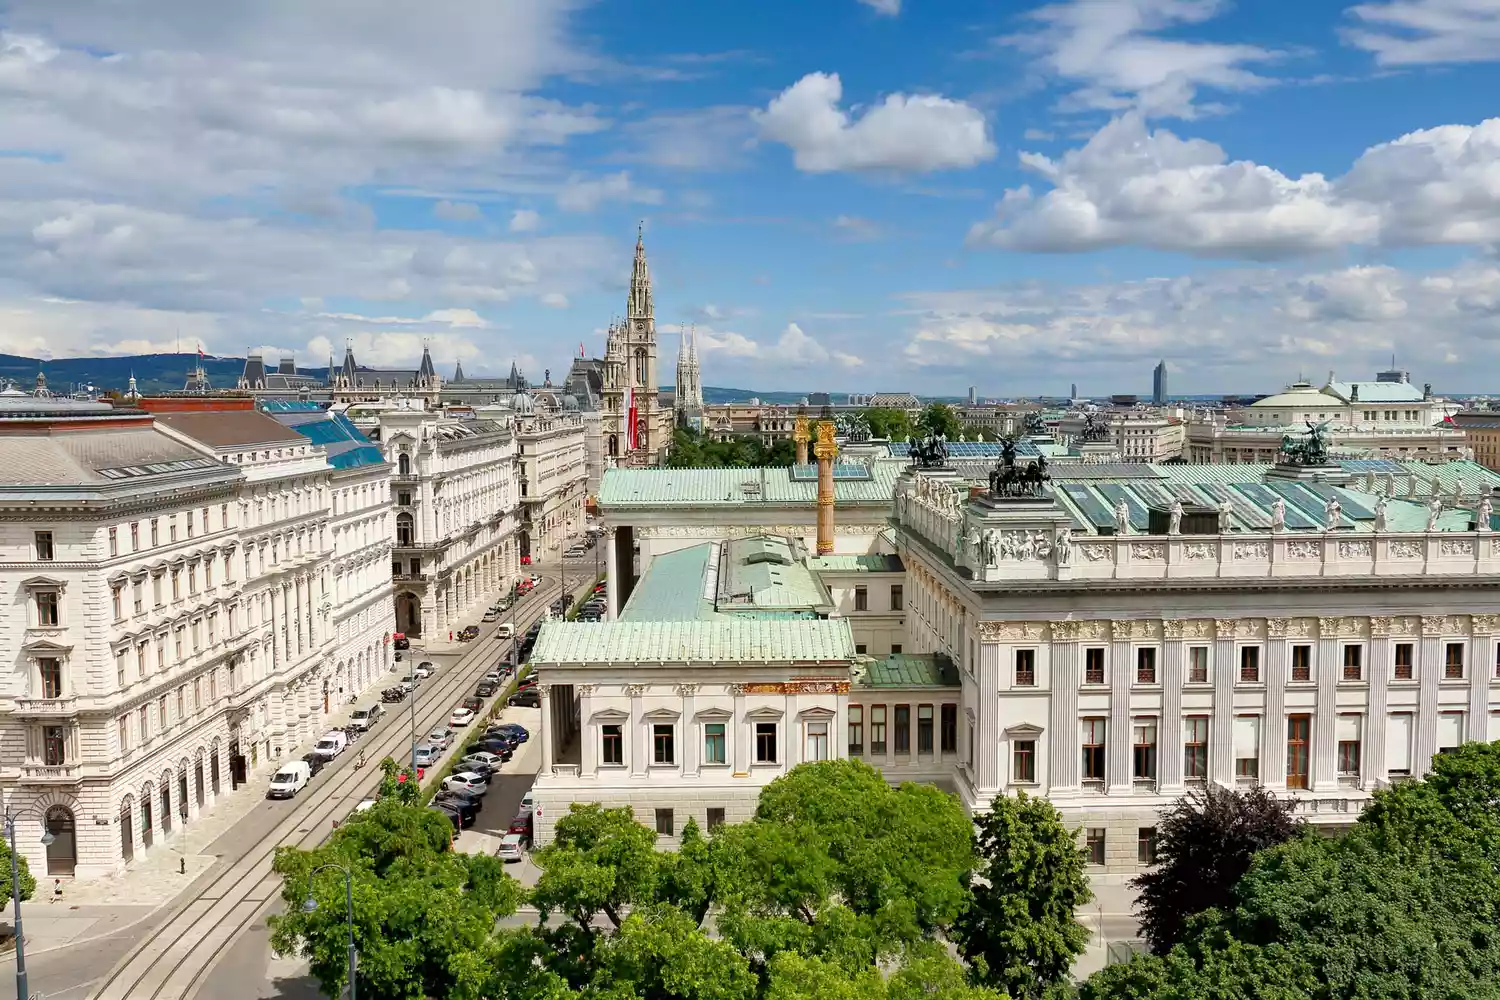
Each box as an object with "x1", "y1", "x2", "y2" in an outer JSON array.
[{"x1": 92, "y1": 579, "x2": 563, "y2": 1000}]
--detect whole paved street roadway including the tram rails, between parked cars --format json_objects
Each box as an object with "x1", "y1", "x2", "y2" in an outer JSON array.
[{"x1": 27, "y1": 579, "x2": 573, "y2": 1000}]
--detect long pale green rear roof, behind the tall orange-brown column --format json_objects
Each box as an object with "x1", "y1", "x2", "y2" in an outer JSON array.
[{"x1": 599, "y1": 459, "x2": 906, "y2": 511}]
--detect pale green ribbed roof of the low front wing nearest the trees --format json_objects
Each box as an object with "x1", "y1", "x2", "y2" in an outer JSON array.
[{"x1": 531, "y1": 615, "x2": 855, "y2": 666}]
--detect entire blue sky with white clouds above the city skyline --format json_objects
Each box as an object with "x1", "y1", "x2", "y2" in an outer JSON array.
[{"x1": 0, "y1": 0, "x2": 1500, "y2": 397}]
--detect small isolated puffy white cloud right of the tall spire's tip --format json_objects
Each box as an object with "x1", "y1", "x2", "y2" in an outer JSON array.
[{"x1": 755, "y1": 73, "x2": 995, "y2": 174}]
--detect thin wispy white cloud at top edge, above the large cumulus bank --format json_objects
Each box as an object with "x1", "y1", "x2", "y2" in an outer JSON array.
[{"x1": 999, "y1": 0, "x2": 1278, "y2": 117}]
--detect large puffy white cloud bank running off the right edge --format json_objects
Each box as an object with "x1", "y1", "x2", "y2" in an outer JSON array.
[{"x1": 969, "y1": 112, "x2": 1500, "y2": 259}]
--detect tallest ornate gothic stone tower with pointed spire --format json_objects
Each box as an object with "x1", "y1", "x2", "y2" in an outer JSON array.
[{"x1": 602, "y1": 229, "x2": 672, "y2": 465}]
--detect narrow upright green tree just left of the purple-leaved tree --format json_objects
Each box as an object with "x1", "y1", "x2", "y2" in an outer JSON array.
[{"x1": 953, "y1": 792, "x2": 1094, "y2": 1000}]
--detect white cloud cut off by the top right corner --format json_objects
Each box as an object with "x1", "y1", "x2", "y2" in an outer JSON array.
[{"x1": 1344, "y1": 0, "x2": 1500, "y2": 66}]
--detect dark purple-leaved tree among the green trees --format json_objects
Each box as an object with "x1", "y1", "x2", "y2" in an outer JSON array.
[{"x1": 1131, "y1": 784, "x2": 1301, "y2": 955}]
